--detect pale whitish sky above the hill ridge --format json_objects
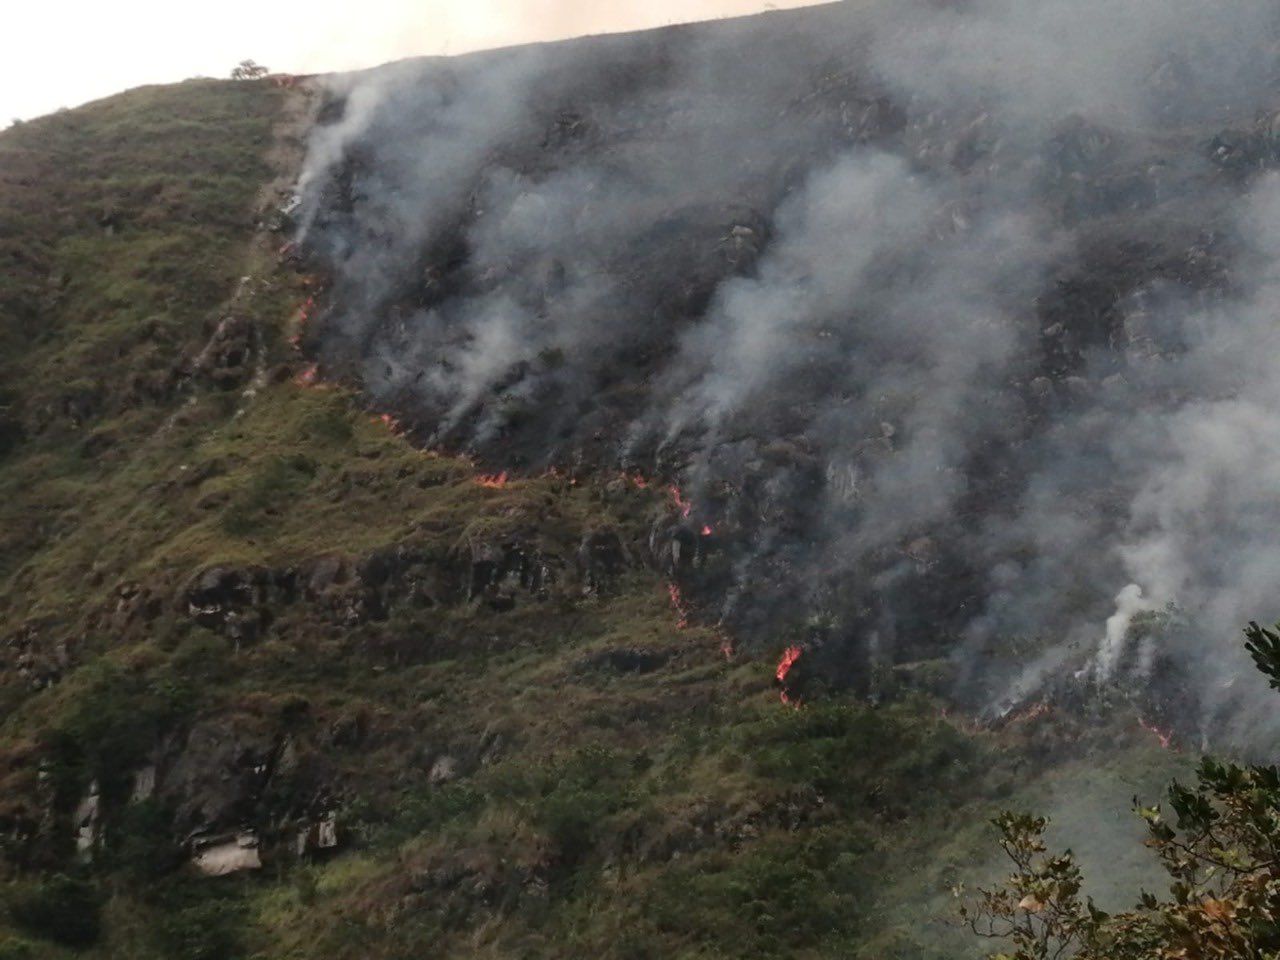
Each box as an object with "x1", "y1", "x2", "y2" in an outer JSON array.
[{"x1": 0, "y1": 0, "x2": 818, "y2": 128}]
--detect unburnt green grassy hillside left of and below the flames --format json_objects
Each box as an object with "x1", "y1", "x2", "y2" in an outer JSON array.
[{"x1": 0, "y1": 7, "x2": 1239, "y2": 960}]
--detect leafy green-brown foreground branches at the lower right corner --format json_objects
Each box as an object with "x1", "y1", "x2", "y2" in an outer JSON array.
[{"x1": 960, "y1": 623, "x2": 1280, "y2": 960}]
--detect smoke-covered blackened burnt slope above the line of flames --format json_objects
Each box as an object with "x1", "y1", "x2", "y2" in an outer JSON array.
[{"x1": 300, "y1": 0, "x2": 1280, "y2": 742}]
